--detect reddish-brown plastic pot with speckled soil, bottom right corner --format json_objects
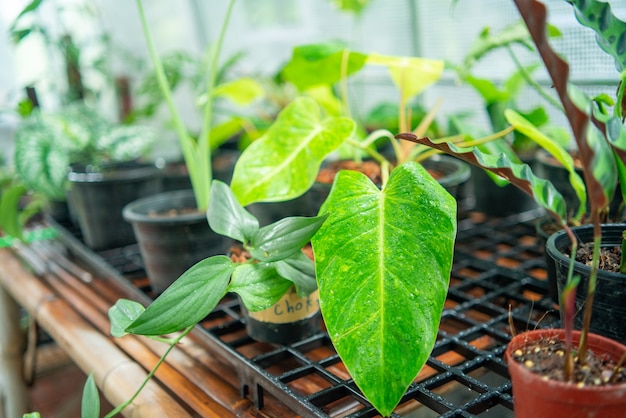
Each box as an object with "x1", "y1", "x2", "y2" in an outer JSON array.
[{"x1": 505, "y1": 329, "x2": 626, "y2": 418}]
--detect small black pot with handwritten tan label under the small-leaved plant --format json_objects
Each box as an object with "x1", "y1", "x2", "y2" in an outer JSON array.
[{"x1": 236, "y1": 287, "x2": 322, "y2": 344}]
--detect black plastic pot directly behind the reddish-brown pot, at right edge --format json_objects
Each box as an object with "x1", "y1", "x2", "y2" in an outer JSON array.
[{"x1": 546, "y1": 224, "x2": 626, "y2": 343}]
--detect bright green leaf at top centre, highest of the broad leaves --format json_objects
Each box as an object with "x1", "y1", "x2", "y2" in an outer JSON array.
[{"x1": 282, "y1": 42, "x2": 367, "y2": 90}]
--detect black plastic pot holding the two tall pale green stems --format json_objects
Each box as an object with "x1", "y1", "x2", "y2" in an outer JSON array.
[{"x1": 123, "y1": 190, "x2": 229, "y2": 294}]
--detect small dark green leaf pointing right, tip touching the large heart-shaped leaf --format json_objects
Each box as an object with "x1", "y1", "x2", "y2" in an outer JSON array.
[{"x1": 248, "y1": 215, "x2": 327, "y2": 262}]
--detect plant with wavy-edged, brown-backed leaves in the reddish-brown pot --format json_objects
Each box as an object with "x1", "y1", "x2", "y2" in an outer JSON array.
[{"x1": 401, "y1": 0, "x2": 626, "y2": 417}]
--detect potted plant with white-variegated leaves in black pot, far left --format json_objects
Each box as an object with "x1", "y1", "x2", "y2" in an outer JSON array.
[{"x1": 14, "y1": 102, "x2": 160, "y2": 250}]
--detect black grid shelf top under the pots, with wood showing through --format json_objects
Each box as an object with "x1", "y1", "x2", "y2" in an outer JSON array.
[{"x1": 51, "y1": 212, "x2": 559, "y2": 417}]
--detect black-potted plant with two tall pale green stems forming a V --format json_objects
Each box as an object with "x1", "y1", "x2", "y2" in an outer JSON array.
[{"x1": 123, "y1": 0, "x2": 268, "y2": 294}]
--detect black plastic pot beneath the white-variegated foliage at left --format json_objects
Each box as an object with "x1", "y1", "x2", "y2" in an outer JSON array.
[{"x1": 68, "y1": 163, "x2": 161, "y2": 250}]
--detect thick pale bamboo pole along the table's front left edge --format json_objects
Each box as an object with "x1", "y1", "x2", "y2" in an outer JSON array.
[{"x1": 0, "y1": 249, "x2": 189, "y2": 417}]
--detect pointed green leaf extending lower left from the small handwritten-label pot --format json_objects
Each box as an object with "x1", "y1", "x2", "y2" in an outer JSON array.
[{"x1": 125, "y1": 255, "x2": 234, "y2": 335}]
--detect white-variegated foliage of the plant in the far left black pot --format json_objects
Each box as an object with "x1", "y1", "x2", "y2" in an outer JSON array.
[{"x1": 14, "y1": 103, "x2": 154, "y2": 200}]
